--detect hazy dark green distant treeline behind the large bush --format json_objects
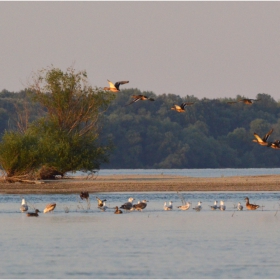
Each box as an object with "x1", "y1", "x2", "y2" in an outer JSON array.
[{"x1": 0, "y1": 89, "x2": 280, "y2": 168}]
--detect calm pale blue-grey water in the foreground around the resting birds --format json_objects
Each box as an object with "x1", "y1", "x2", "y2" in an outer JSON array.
[{"x1": 0, "y1": 192, "x2": 280, "y2": 279}]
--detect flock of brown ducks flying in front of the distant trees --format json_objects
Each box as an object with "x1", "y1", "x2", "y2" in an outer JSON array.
[{"x1": 104, "y1": 80, "x2": 280, "y2": 150}]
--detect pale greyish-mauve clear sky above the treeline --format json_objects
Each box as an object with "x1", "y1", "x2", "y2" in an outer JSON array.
[{"x1": 0, "y1": 1, "x2": 280, "y2": 100}]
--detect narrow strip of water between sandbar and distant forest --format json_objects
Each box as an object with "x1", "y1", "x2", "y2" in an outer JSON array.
[{"x1": 70, "y1": 168, "x2": 280, "y2": 177}]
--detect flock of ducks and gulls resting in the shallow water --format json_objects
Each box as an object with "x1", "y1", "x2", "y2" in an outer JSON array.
[{"x1": 20, "y1": 192, "x2": 260, "y2": 217}]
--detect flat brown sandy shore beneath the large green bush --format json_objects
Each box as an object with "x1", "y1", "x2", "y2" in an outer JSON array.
[{"x1": 0, "y1": 175, "x2": 280, "y2": 194}]
